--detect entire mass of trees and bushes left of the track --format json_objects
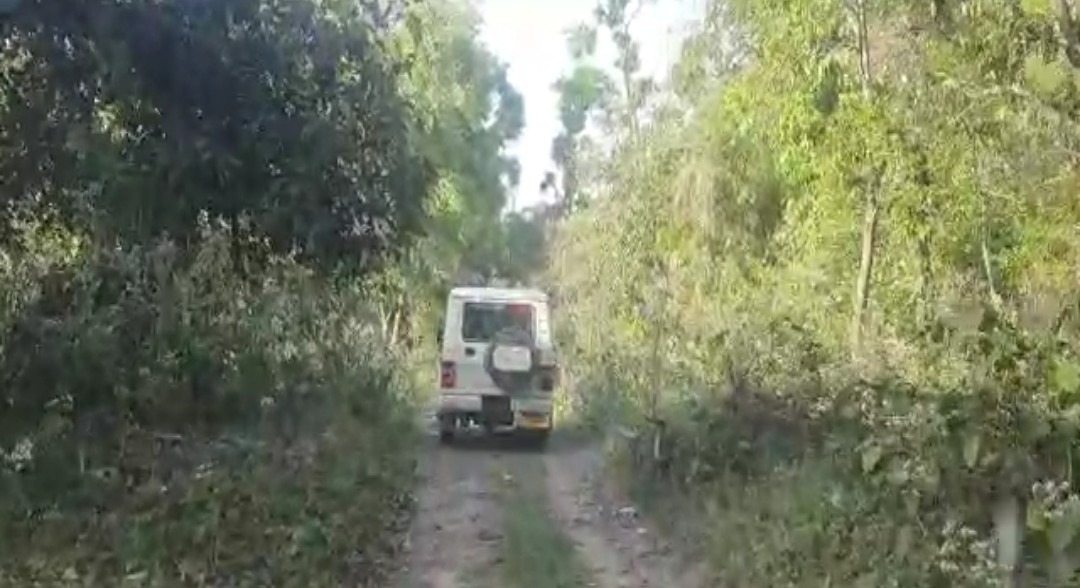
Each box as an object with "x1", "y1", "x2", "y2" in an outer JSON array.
[{"x1": 0, "y1": 0, "x2": 522, "y2": 587}]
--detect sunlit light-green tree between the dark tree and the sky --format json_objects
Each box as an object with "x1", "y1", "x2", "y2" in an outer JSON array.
[{"x1": 369, "y1": 0, "x2": 525, "y2": 339}]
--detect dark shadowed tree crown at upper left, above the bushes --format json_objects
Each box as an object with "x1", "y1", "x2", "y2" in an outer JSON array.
[{"x1": 0, "y1": 0, "x2": 428, "y2": 268}]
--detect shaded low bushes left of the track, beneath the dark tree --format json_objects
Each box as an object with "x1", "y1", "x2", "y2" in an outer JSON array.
[{"x1": 0, "y1": 233, "x2": 414, "y2": 587}]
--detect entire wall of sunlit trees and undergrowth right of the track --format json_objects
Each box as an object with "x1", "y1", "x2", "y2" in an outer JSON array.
[{"x1": 550, "y1": 0, "x2": 1080, "y2": 586}]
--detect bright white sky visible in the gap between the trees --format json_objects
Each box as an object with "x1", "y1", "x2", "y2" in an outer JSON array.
[{"x1": 478, "y1": 0, "x2": 701, "y2": 210}]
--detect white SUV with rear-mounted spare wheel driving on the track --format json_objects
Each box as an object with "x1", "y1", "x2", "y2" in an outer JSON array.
[{"x1": 438, "y1": 288, "x2": 558, "y2": 444}]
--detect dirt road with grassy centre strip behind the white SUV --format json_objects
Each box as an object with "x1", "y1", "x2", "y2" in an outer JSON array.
[{"x1": 395, "y1": 425, "x2": 706, "y2": 588}]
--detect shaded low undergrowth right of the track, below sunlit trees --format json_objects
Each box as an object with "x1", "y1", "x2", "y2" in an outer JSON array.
[{"x1": 580, "y1": 311, "x2": 1080, "y2": 587}]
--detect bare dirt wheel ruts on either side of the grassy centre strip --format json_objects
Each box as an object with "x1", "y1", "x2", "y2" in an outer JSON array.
[{"x1": 393, "y1": 428, "x2": 707, "y2": 588}]
